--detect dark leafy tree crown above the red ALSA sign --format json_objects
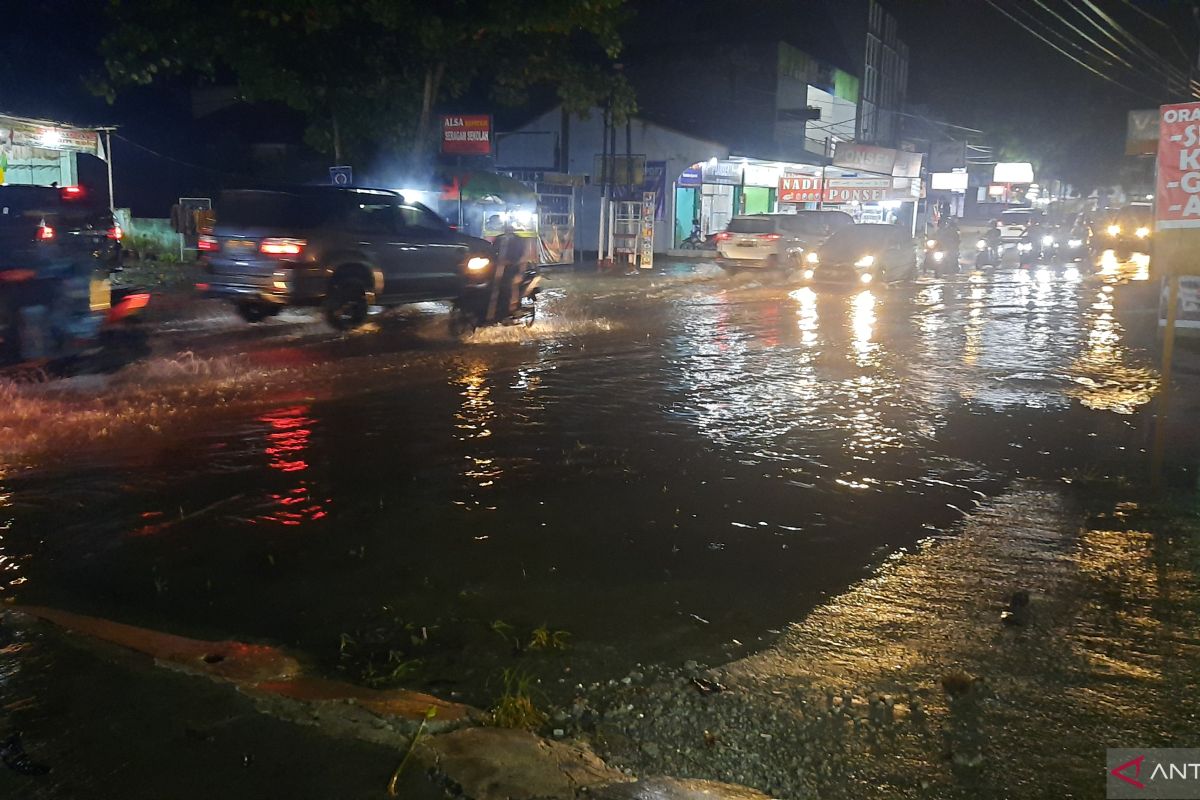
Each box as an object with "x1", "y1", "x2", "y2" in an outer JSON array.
[{"x1": 101, "y1": 0, "x2": 635, "y2": 163}]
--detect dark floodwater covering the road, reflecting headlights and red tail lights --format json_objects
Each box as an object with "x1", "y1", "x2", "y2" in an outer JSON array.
[{"x1": 0, "y1": 259, "x2": 1157, "y2": 704}]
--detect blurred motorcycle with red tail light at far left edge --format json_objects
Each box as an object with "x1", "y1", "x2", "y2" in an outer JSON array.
[{"x1": 0, "y1": 266, "x2": 150, "y2": 375}]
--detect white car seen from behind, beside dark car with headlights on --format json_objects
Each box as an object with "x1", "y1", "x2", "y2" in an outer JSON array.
[{"x1": 716, "y1": 211, "x2": 854, "y2": 270}]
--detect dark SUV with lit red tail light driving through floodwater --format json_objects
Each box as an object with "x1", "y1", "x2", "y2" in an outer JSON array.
[{"x1": 199, "y1": 186, "x2": 494, "y2": 330}]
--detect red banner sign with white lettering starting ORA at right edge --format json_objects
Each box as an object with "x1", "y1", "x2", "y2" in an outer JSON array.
[{"x1": 1154, "y1": 103, "x2": 1200, "y2": 229}]
